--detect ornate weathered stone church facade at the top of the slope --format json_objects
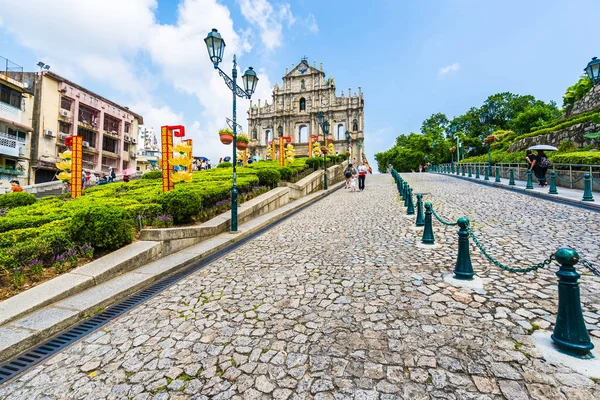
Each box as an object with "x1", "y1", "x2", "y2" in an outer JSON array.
[{"x1": 248, "y1": 59, "x2": 364, "y2": 161}]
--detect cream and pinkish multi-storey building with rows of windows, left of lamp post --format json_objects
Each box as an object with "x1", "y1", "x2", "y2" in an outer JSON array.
[{"x1": 23, "y1": 70, "x2": 143, "y2": 184}]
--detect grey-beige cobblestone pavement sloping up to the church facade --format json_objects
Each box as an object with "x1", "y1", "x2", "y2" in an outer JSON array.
[{"x1": 0, "y1": 174, "x2": 600, "y2": 400}]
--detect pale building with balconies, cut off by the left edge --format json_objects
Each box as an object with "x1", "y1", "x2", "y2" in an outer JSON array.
[{"x1": 0, "y1": 57, "x2": 33, "y2": 192}]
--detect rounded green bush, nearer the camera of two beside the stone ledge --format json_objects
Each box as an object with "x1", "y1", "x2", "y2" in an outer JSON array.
[{"x1": 69, "y1": 204, "x2": 133, "y2": 250}]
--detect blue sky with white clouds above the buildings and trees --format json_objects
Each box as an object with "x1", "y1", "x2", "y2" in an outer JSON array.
[{"x1": 0, "y1": 0, "x2": 600, "y2": 164}]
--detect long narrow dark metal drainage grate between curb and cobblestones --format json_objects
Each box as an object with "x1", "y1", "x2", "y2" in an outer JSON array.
[{"x1": 0, "y1": 186, "x2": 341, "y2": 384}]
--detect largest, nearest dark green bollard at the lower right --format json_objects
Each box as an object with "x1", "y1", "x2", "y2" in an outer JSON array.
[{"x1": 551, "y1": 248, "x2": 594, "y2": 357}]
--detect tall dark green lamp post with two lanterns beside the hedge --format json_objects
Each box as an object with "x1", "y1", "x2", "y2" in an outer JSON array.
[{"x1": 204, "y1": 29, "x2": 258, "y2": 232}]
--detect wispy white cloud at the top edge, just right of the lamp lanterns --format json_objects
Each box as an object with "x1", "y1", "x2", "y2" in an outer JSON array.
[{"x1": 238, "y1": 0, "x2": 296, "y2": 50}]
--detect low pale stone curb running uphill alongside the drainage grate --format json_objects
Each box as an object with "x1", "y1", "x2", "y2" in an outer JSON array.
[{"x1": 0, "y1": 182, "x2": 344, "y2": 362}]
